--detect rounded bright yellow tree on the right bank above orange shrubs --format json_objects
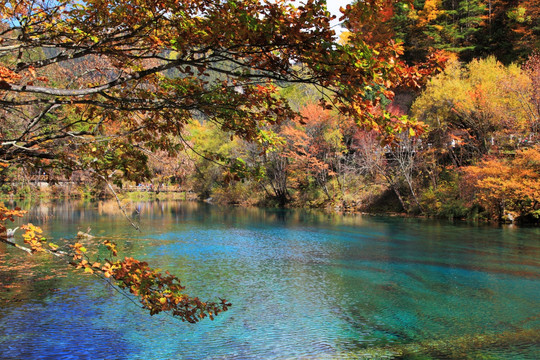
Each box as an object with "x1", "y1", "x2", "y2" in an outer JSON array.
[{"x1": 412, "y1": 57, "x2": 536, "y2": 159}]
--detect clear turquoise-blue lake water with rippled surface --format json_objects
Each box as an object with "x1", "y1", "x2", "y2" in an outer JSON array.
[{"x1": 0, "y1": 202, "x2": 540, "y2": 359}]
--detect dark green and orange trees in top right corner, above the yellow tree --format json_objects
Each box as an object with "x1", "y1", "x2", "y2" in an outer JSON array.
[{"x1": 392, "y1": 0, "x2": 540, "y2": 64}]
